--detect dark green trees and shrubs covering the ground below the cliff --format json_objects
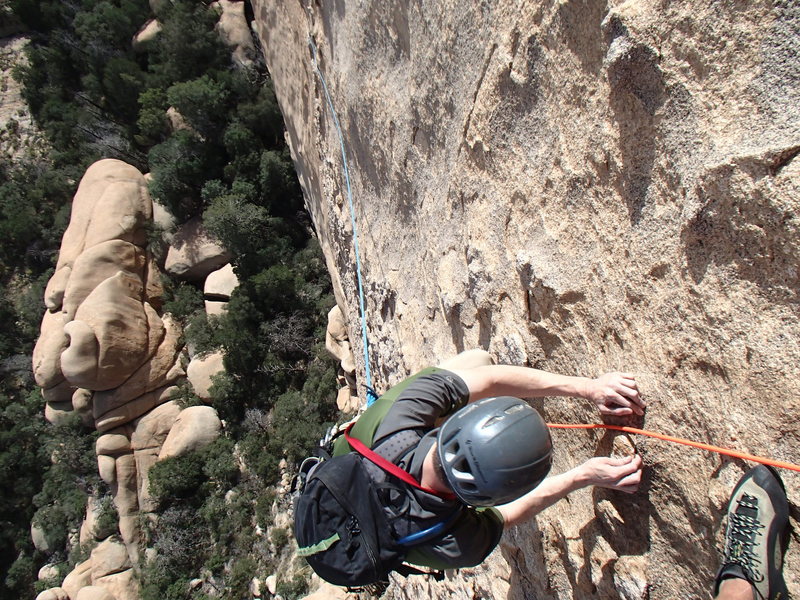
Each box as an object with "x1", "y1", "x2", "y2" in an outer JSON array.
[{"x1": 9, "y1": 0, "x2": 336, "y2": 600}]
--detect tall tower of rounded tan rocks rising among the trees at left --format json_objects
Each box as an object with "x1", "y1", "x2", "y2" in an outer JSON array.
[{"x1": 31, "y1": 160, "x2": 221, "y2": 600}]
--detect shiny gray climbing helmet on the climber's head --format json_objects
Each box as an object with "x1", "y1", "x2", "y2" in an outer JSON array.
[{"x1": 436, "y1": 396, "x2": 553, "y2": 506}]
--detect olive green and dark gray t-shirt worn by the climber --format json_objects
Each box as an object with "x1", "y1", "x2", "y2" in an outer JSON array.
[{"x1": 334, "y1": 368, "x2": 504, "y2": 569}]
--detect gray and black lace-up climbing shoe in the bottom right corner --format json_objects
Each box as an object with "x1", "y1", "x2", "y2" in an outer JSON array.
[{"x1": 714, "y1": 465, "x2": 789, "y2": 600}]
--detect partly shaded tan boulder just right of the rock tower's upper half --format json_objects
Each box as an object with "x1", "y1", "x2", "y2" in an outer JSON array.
[{"x1": 164, "y1": 218, "x2": 231, "y2": 281}]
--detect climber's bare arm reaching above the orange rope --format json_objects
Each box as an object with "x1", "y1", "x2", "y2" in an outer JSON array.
[{"x1": 454, "y1": 365, "x2": 645, "y2": 415}]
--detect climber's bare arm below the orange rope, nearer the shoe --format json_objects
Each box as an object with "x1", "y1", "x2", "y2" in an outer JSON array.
[{"x1": 496, "y1": 454, "x2": 642, "y2": 526}]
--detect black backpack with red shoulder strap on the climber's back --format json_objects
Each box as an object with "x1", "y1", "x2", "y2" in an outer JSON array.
[{"x1": 294, "y1": 426, "x2": 463, "y2": 588}]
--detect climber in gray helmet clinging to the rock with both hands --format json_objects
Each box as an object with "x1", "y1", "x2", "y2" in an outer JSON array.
[{"x1": 334, "y1": 350, "x2": 645, "y2": 569}]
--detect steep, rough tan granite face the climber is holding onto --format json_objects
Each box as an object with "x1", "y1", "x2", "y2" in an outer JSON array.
[{"x1": 253, "y1": 0, "x2": 800, "y2": 599}]
